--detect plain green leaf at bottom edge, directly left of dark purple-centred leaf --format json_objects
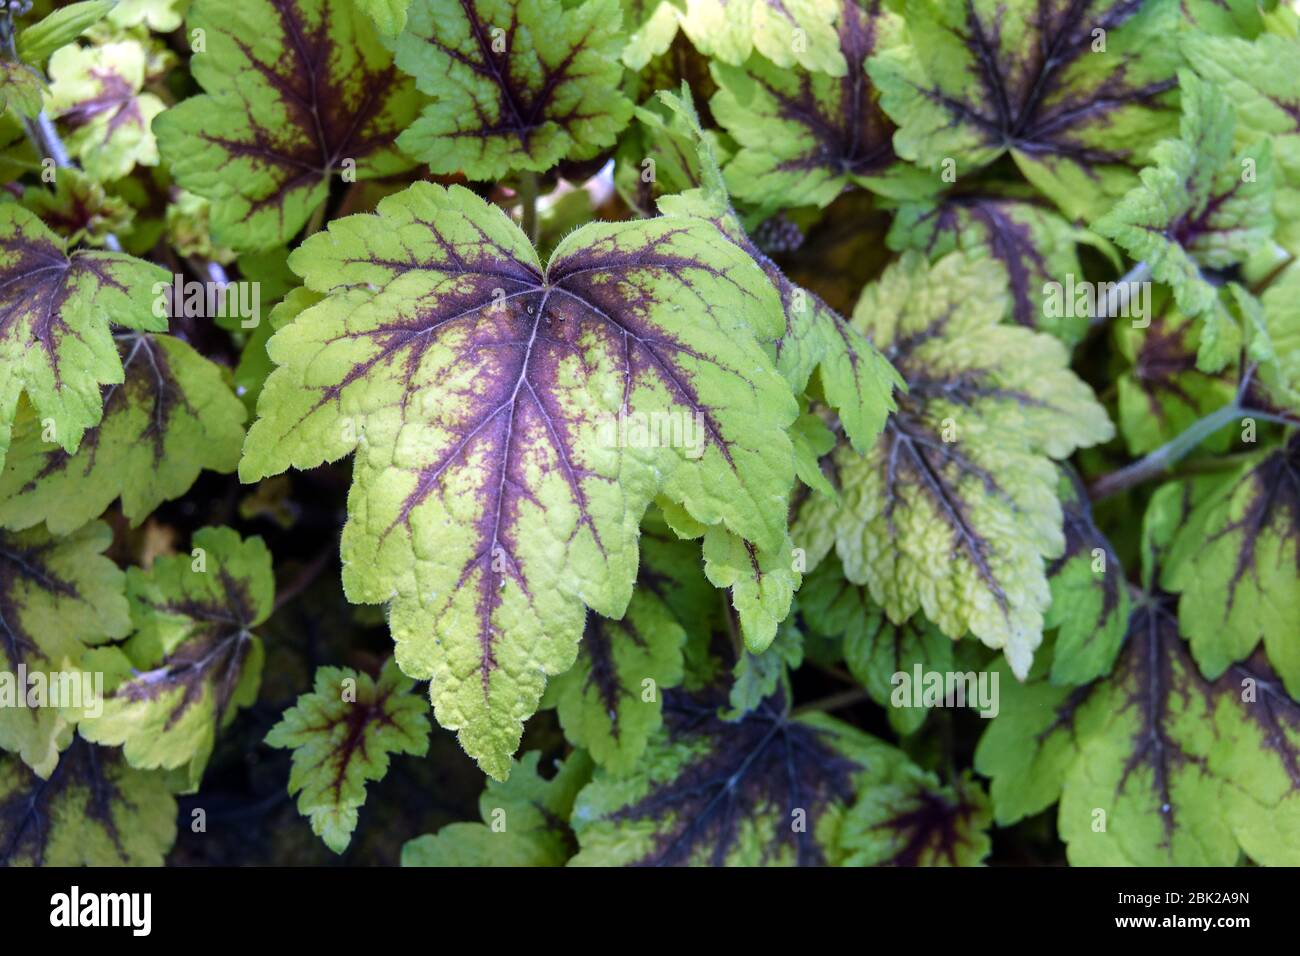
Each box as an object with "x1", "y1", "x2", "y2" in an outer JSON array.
[{"x1": 402, "y1": 750, "x2": 592, "y2": 866}]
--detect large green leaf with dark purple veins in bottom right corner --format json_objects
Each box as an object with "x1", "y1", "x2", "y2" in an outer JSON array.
[{"x1": 975, "y1": 616, "x2": 1300, "y2": 866}]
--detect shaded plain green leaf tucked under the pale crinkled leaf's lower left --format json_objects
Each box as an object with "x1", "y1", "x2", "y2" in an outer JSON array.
[{"x1": 800, "y1": 558, "x2": 953, "y2": 736}]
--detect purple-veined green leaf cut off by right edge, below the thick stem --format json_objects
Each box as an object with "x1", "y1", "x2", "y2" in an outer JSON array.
[{"x1": 1161, "y1": 434, "x2": 1300, "y2": 697}]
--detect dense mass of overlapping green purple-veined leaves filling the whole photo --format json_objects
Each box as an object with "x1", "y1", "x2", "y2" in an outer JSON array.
[{"x1": 0, "y1": 0, "x2": 1300, "y2": 866}]
